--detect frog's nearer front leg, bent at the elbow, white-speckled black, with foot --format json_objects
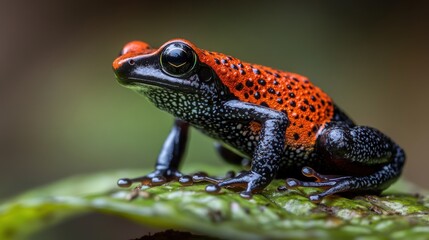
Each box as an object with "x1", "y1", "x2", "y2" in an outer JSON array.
[{"x1": 206, "y1": 100, "x2": 289, "y2": 198}]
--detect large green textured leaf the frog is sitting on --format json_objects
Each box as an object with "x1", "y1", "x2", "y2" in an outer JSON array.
[{"x1": 0, "y1": 166, "x2": 429, "y2": 239}]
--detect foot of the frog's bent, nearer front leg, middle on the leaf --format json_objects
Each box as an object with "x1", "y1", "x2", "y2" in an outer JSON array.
[{"x1": 199, "y1": 171, "x2": 269, "y2": 199}]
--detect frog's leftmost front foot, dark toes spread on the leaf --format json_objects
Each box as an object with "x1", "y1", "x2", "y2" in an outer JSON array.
[{"x1": 117, "y1": 169, "x2": 186, "y2": 188}]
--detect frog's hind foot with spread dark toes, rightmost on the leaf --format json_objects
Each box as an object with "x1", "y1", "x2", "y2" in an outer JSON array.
[{"x1": 279, "y1": 167, "x2": 356, "y2": 202}]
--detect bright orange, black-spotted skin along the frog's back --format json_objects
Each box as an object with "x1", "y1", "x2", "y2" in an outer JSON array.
[{"x1": 197, "y1": 50, "x2": 334, "y2": 148}]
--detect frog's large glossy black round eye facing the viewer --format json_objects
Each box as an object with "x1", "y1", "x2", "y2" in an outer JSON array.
[{"x1": 160, "y1": 42, "x2": 197, "y2": 77}]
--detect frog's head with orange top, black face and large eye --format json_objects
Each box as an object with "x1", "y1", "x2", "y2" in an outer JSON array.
[{"x1": 113, "y1": 39, "x2": 222, "y2": 93}]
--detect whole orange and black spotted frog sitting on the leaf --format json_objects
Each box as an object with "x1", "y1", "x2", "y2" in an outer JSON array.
[{"x1": 113, "y1": 38, "x2": 406, "y2": 202}]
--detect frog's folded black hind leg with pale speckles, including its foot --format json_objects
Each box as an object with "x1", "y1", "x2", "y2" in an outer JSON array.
[{"x1": 286, "y1": 122, "x2": 405, "y2": 202}]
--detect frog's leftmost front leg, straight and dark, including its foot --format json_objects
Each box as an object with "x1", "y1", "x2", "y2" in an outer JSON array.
[{"x1": 118, "y1": 119, "x2": 189, "y2": 187}]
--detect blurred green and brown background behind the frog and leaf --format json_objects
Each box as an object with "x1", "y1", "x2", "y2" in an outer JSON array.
[{"x1": 0, "y1": 0, "x2": 429, "y2": 239}]
